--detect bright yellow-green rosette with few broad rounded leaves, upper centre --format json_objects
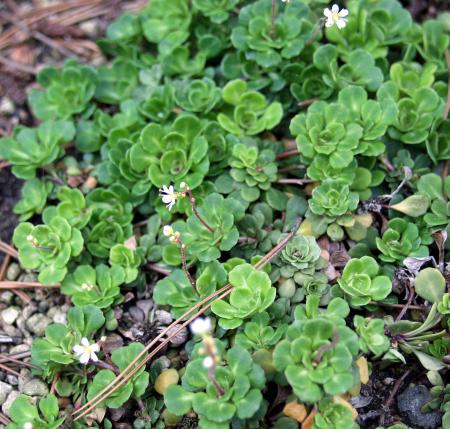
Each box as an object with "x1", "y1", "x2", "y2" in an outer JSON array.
[{"x1": 217, "y1": 79, "x2": 283, "y2": 137}]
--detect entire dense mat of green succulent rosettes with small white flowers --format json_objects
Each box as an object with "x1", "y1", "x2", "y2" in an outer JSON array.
[{"x1": 0, "y1": 0, "x2": 450, "y2": 429}]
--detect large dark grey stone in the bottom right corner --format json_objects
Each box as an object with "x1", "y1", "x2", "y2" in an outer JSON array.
[{"x1": 397, "y1": 385, "x2": 442, "y2": 429}]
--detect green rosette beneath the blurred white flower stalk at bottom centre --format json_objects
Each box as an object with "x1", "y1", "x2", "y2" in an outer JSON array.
[{"x1": 164, "y1": 345, "x2": 265, "y2": 429}]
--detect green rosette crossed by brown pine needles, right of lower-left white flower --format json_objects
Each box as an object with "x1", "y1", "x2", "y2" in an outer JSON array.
[{"x1": 87, "y1": 343, "x2": 149, "y2": 408}]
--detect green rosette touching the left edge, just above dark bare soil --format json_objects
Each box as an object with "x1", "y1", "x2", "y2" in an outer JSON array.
[{"x1": 0, "y1": 121, "x2": 75, "y2": 179}]
